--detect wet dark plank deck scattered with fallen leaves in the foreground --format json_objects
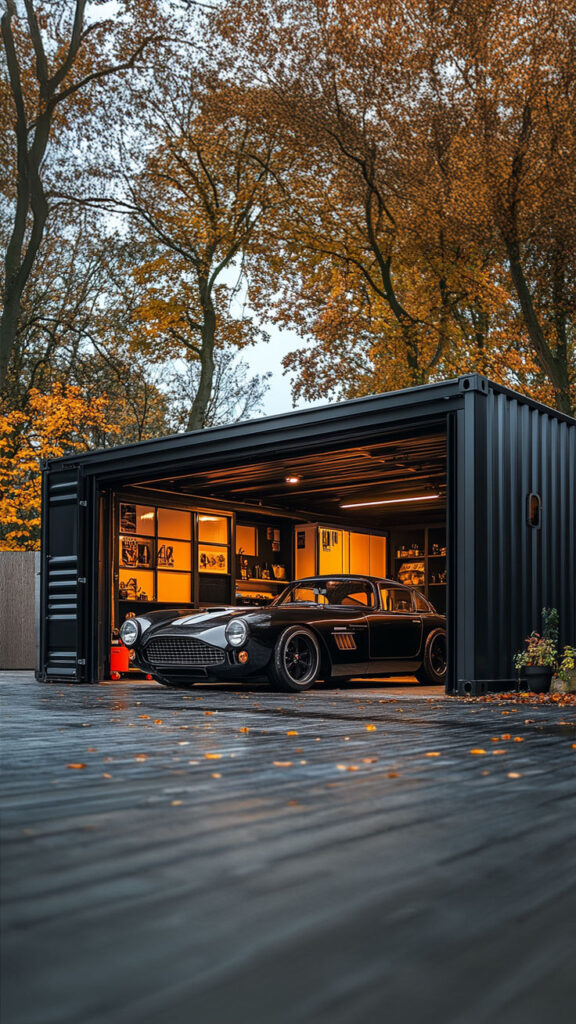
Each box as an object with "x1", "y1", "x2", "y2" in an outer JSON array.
[{"x1": 0, "y1": 673, "x2": 576, "y2": 1024}]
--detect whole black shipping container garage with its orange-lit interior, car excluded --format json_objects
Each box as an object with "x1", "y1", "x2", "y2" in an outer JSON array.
[{"x1": 39, "y1": 374, "x2": 576, "y2": 693}]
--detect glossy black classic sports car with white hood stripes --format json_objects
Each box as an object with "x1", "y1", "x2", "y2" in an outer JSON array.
[{"x1": 120, "y1": 575, "x2": 446, "y2": 691}]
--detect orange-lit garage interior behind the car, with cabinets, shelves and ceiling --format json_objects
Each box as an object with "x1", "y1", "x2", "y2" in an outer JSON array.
[{"x1": 108, "y1": 425, "x2": 448, "y2": 684}]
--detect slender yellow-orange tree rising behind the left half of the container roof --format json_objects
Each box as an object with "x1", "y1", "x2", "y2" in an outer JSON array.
[{"x1": 93, "y1": 63, "x2": 278, "y2": 430}]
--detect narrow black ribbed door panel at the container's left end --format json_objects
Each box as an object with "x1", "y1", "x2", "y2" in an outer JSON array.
[{"x1": 40, "y1": 468, "x2": 87, "y2": 682}]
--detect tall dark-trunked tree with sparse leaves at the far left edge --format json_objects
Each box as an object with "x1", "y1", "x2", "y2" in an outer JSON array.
[{"x1": 0, "y1": 0, "x2": 159, "y2": 387}]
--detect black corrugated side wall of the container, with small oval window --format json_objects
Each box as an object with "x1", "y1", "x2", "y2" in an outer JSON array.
[{"x1": 455, "y1": 388, "x2": 576, "y2": 691}]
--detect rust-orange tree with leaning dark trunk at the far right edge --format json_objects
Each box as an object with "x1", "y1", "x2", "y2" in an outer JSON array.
[{"x1": 444, "y1": 0, "x2": 576, "y2": 413}]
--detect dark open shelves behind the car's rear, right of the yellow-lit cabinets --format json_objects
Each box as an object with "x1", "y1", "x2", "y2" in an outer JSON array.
[{"x1": 390, "y1": 526, "x2": 446, "y2": 612}]
